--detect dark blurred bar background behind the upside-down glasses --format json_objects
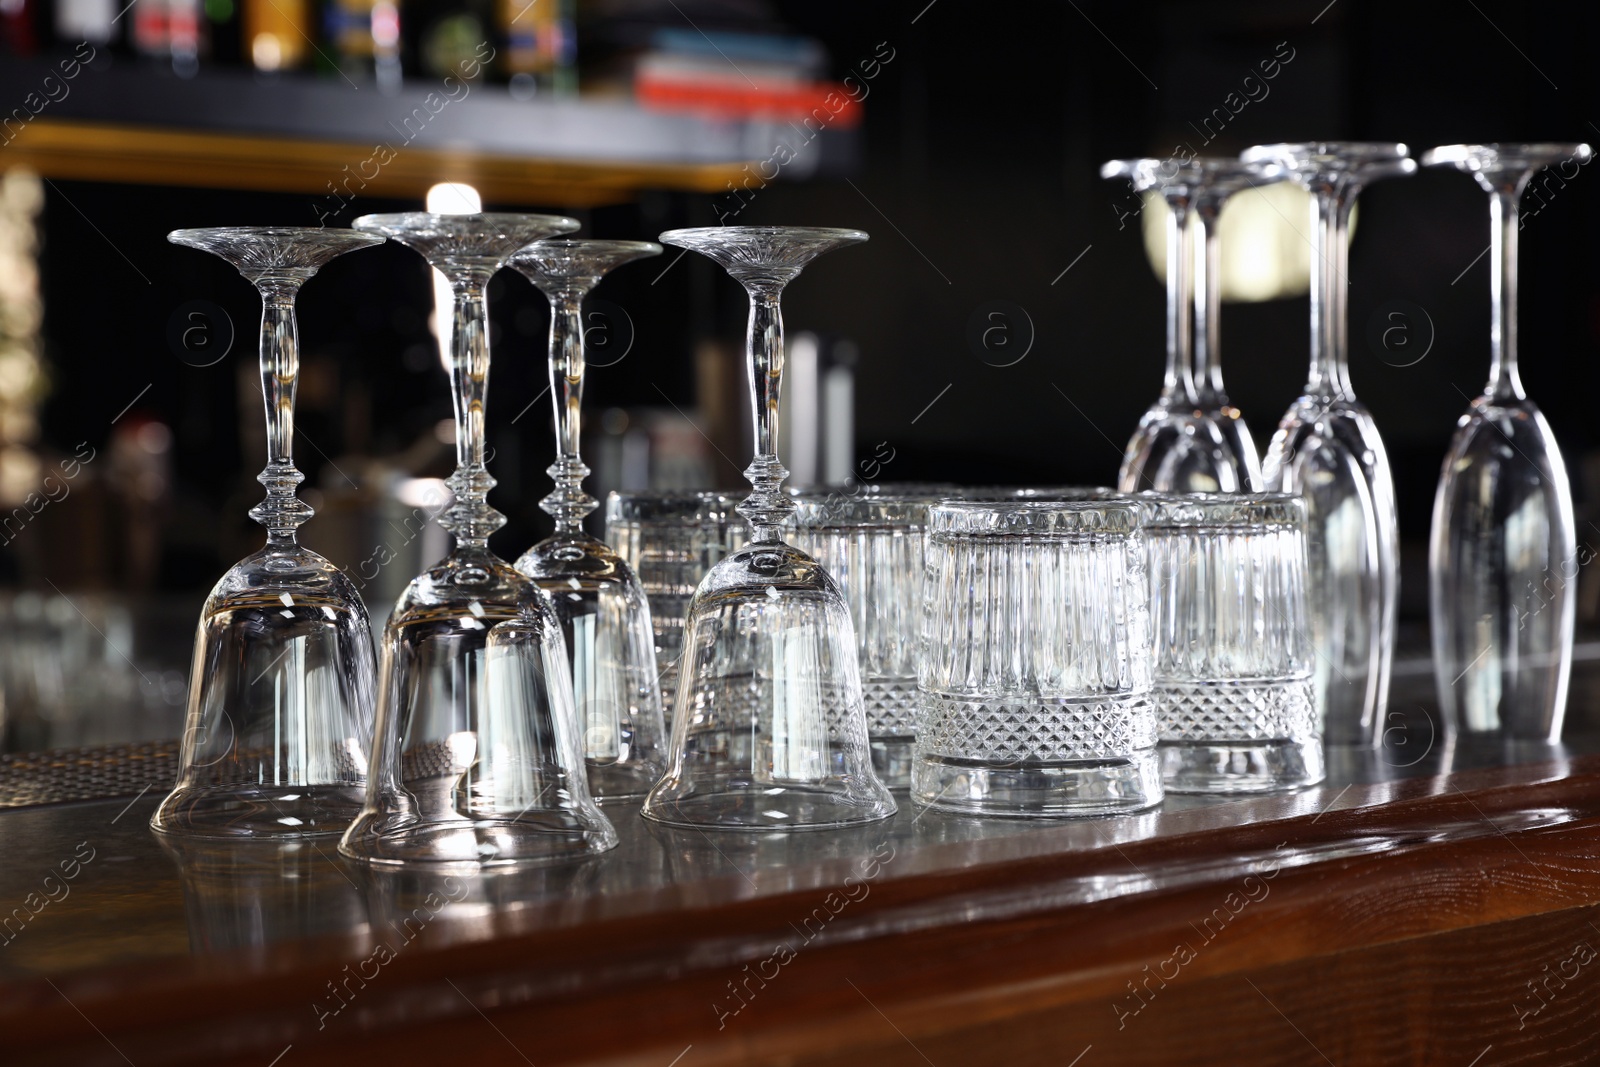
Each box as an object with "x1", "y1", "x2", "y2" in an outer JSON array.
[{"x1": 0, "y1": 0, "x2": 1600, "y2": 748}]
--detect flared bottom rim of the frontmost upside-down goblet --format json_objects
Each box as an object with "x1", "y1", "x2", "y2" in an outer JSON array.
[{"x1": 339, "y1": 811, "x2": 618, "y2": 867}]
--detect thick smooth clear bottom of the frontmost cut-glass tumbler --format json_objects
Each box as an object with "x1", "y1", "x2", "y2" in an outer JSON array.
[{"x1": 910, "y1": 749, "x2": 1163, "y2": 817}]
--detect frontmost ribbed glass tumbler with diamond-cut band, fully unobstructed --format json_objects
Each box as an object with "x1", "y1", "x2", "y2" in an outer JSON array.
[{"x1": 910, "y1": 499, "x2": 1162, "y2": 816}]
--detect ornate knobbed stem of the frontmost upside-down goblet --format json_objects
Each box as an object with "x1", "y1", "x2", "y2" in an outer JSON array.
[{"x1": 440, "y1": 267, "x2": 506, "y2": 550}]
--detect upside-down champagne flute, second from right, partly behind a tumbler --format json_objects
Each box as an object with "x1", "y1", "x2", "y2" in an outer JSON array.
[{"x1": 1243, "y1": 142, "x2": 1416, "y2": 749}]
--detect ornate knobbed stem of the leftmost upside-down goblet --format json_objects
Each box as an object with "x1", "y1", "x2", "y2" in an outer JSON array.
[{"x1": 250, "y1": 277, "x2": 312, "y2": 547}]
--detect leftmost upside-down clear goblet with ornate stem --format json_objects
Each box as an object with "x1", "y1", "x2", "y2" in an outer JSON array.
[{"x1": 150, "y1": 226, "x2": 382, "y2": 837}]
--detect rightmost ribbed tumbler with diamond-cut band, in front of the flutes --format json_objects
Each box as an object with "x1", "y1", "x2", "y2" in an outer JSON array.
[{"x1": 1141, "y1": 493, "x2": 1323, "y2": 793}]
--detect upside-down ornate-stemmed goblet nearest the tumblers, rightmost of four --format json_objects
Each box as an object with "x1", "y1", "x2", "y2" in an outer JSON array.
[{"x1": 643, "y1": 226, "x2": 894, "y2": 830}]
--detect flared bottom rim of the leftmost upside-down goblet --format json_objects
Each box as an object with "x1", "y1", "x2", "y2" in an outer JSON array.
[{"x1": 150, "y1": 782, "x2": 366, "y2": 840}]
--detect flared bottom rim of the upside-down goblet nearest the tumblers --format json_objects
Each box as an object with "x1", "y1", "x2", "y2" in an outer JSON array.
[{"x1": 642, "y1": 779, "x2": 894, "y2": 832}]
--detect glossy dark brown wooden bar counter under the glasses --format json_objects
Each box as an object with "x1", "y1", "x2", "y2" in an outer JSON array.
[{"x1": 0, "y1": 700, "x2": 1600, "y2": 1067}]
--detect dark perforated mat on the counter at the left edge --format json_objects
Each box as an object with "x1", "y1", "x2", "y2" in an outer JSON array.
[{"x1": 0, "y1": 741, "x2": 178, "y2": 808}]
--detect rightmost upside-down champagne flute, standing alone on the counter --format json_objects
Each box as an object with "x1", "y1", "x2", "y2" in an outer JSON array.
[{"x1": 1422, "y1": 144, "x2": 1594, "y2": 744}]
